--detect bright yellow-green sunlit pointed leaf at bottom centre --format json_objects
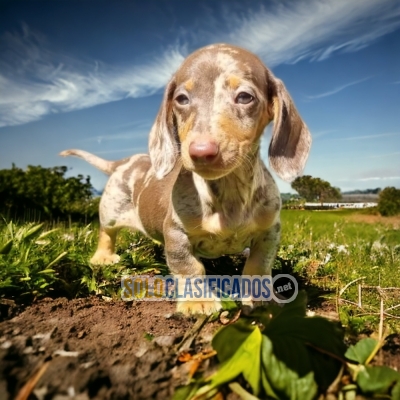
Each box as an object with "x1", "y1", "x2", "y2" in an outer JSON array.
[{"x1": 203, "y1": 325, "x2": 262, "y2": 395}]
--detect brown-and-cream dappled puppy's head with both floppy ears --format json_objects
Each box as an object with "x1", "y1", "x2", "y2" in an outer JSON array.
[{"x1": 150, "y1": 44, "x2": 311, "y2": 181}]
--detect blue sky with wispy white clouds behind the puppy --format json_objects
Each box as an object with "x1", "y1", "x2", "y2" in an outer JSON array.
[{"x1": 0, "y1": 0, "x2": 400, "y2": 192}]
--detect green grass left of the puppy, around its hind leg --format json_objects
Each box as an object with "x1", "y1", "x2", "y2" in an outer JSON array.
[{"x1": 0, "y1": 221, "x2": 166, "y2": 302}]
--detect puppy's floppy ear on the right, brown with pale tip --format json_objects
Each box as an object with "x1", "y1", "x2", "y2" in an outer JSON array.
[{"x1": 267, "y1": 71, "x2": 311, "y2": 182}]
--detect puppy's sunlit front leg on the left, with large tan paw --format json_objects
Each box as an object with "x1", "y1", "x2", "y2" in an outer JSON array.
[{"x1": 164, "y1": 226, "x2": 222, "y2": 315}]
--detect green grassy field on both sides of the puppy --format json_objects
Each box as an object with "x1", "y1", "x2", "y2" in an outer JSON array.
[{"x1": 0, "y1": 210, "x2": 400, "y2": 329}]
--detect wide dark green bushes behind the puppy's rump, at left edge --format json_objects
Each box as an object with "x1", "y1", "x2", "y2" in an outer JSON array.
[{"x1": 0, "y1": 164, "x2": 97, "y2": 222}]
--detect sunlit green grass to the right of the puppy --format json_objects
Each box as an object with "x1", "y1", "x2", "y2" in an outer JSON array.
[{"x1": 278, "y1": 210, "x2": 400, "y2": 330}]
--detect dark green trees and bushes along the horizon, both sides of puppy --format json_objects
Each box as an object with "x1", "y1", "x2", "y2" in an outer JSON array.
[{"x1": 0, "y1": 164, "x2": 400, "y2": 222}]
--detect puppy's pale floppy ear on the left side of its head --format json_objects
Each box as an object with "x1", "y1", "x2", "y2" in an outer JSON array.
[{"x1": 149, "y1": 78, "x2": 179, "y2": 179}]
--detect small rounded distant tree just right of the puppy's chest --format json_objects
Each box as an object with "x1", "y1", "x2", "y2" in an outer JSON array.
[{"x1": 292, "y1": 175, "x2": 342, "y2": 204}]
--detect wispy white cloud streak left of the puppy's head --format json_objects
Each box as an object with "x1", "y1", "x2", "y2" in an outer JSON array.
[{"x1": 0, "y1": 26, "x2": 184, "y2": 127}]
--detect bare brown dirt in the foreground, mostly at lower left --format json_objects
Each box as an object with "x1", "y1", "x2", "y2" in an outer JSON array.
[{"x1": 0, "y1": 297, "x2": 400, "y2": 400}]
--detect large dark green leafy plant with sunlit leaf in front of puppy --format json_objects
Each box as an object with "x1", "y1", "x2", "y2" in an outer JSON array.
[{"x1": 174, "y1": 293, "x2": 345, "y2": 400}]
